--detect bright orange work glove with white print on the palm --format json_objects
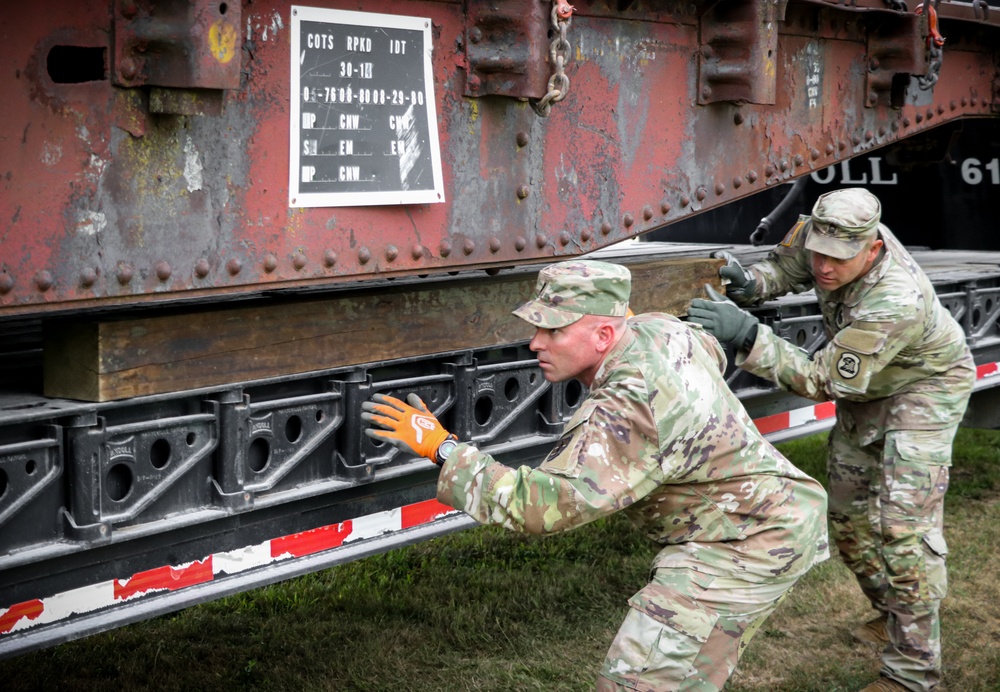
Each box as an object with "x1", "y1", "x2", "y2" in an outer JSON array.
[{"x1": 361, "y1": 394, "x2": 458, "y2": 463}]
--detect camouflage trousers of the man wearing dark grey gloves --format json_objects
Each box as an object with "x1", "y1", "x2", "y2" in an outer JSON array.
[{"x1": 828, "y1": 421, "x2": 957, "y2": 690}]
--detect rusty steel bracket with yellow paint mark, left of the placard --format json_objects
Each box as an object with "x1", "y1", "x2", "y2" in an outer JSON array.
[{"x1": 111, "y1": 0, "x2": 241, "y2": 114}]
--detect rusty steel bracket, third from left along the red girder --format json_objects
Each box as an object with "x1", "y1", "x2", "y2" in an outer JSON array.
[{"x1": 698, "y1": 0, "x2": 787, "y2": 105}]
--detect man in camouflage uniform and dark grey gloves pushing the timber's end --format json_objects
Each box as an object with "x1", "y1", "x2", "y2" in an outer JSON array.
[{"x1": 691, "y1": 188, "x2": 975, "y2": 691}]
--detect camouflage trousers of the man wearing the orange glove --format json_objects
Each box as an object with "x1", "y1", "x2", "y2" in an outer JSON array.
[{"x1": 597, "y1": 568, "x2": 798, "y2": 692}]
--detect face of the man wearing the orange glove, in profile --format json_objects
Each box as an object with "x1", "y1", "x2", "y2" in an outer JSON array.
[{"x1": 528, "y1": 315, "x2": 604, "y2": 387}]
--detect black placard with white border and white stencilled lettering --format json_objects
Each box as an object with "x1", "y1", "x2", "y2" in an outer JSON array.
[{"x1": 288, "y1": 6, "x2": 444, "y2": 207}]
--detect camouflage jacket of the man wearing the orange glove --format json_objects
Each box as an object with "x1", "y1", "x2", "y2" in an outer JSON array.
[{"x1": 438, "y1": 314, "x2": 828, "y2": 582}]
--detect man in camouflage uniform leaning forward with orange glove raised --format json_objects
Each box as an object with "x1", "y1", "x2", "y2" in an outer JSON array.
[{"x1": 362, "y1": 260, "x2": 829, "y2": 692}]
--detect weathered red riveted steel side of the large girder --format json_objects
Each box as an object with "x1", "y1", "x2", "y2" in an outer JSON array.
[{"x1": 0, "y1": 0, "x2": 1000, "y2": 316}]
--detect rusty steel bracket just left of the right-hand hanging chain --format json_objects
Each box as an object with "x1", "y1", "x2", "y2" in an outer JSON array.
[{"x1": 865, "y1": 12, "x2": 927, "y2": 108}]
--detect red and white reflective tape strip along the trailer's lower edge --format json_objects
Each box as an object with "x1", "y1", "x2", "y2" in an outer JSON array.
[{"x1": 0, "y1": 363, "x2": 1000, "y2": 637}]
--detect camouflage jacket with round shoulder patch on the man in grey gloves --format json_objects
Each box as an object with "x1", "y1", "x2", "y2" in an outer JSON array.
[{"x1": 736, "y1": 216, "x2": 975, "y2": 444}]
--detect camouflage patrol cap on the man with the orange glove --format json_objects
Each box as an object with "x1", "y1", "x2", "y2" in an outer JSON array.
[{"x1": 514, "y1": 260, "x2": 632, "y2": 329}]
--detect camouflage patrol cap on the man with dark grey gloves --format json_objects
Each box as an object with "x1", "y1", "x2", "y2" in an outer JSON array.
[{"x1": 806, "y1": 187, "x2": 882, "y2": 259}]
